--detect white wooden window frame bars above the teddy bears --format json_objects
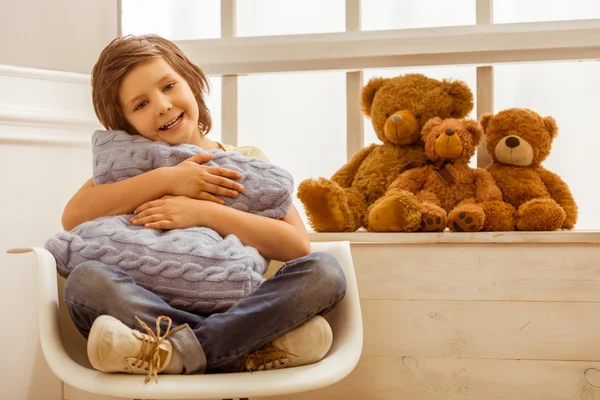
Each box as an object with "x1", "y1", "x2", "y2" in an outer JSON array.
[{"x1": 122, "y1": 0, "x2": 600, "y2": 167}]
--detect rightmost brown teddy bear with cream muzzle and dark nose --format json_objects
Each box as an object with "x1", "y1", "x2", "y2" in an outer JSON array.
[{"x1": 480, "y1": 108, "x2": 577, "y2": 231}]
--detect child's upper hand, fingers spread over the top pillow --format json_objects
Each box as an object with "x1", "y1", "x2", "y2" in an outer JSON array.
[{"x1": 167, "y1": 153, "x2": 244, "y2": 204}]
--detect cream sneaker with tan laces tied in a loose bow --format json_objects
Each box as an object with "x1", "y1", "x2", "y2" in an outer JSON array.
[{"x1": 87, "y1": 315, "x2": 187, "y2": 383}]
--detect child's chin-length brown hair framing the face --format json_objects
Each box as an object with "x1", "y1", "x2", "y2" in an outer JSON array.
[{"x1": 92, "y1": 35, "x2": 212, "y2": 136}]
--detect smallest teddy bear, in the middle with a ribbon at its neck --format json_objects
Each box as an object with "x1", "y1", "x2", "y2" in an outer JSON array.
[{"x1": 369, "y1": 118, "x2": 514, "y2": 232}]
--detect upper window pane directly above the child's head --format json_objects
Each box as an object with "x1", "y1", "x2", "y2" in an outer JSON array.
[{"x1": 121, "y1": 0, "x2": 221, "y2": 40}]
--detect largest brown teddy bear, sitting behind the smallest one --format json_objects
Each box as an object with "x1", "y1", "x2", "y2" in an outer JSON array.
[{"x1": 298, "y1": 74, "x2": 473, "y2": 232}]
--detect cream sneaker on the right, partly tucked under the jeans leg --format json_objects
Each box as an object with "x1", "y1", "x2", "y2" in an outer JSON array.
[{"x1": 245, "y1": 315, "x2": 333, "y2": 371}]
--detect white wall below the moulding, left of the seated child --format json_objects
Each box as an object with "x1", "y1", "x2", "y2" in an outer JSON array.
[{"x1": 0, "y1": 66, "x2": 99, "y2": 400}]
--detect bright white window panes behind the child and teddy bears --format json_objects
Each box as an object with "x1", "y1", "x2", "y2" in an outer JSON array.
[{"x1": 122, "y1": 0, "x2": 600, "y2": 229}]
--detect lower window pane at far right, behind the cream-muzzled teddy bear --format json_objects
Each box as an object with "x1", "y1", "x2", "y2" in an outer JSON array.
[{"x1": 494, "y1": 62, "x2": 600, "y2": 230}]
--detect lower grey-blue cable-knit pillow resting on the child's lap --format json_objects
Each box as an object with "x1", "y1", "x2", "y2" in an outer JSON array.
[{"x1": 45, "y1": 215, "x2": 267, "y2": 314}]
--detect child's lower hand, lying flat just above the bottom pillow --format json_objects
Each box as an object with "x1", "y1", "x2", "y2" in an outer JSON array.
[{"x1": 130, "y1": 196, "x2": 218, "y2": 229}]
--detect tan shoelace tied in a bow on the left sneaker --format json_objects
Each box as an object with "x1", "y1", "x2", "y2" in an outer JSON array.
[{"x1": 133, "y1": 315, "x2": 187, "y2": 383}]
